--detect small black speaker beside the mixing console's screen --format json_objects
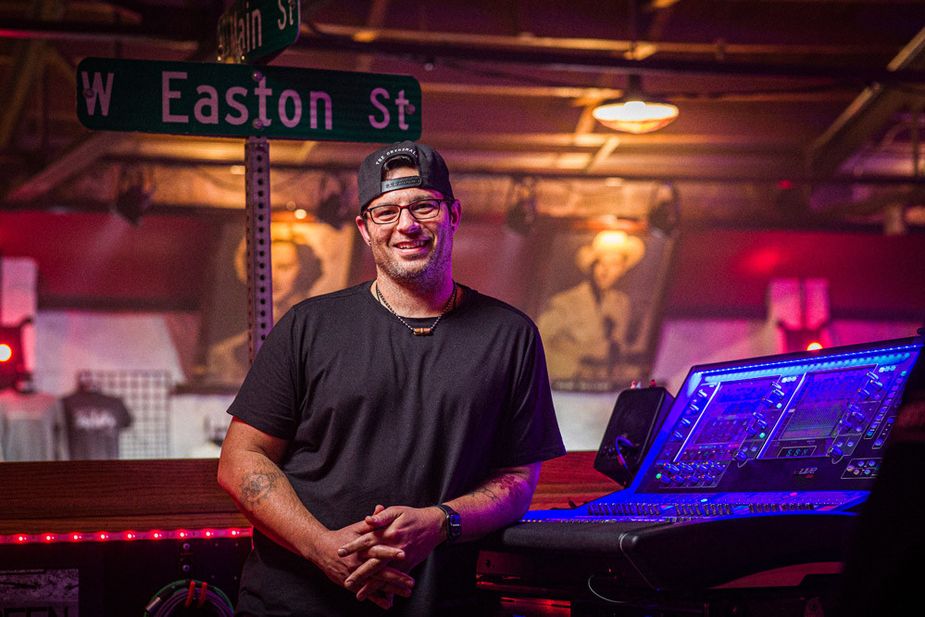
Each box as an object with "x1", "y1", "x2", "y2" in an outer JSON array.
[{"x1": 594, "y1": 387, "x2": 674, "y2": 486}]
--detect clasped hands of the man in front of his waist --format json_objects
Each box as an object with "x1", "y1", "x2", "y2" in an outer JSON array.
[{"x1": 337, "y1": 505, "x2": 444, "y2": 608}]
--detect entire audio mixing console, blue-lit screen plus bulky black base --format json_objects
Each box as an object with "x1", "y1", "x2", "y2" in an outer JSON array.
[{"x1": 478, "y1": 337, "x2": 923, "y2": 617}]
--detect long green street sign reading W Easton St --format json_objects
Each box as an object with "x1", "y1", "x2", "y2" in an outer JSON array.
[{"x1": 77, "y1": 58, "x2": 421, "y2": 143}]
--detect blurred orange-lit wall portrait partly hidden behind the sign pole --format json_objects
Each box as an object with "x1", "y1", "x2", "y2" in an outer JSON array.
[{"x1": 198, "y1": 221, "x2": 356, "y2": 387}]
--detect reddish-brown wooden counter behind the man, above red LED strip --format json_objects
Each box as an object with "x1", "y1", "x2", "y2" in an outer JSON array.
[{"x1": 0, "y1": 452, "x2": 619, "y2": 535}]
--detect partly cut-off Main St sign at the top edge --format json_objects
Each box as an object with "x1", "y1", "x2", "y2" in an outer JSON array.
[{"x1": 218, "y1": 0, "x2": 301, "y2": 62}]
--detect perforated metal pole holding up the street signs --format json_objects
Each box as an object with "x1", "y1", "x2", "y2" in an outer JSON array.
[{"x1": 244, "y1": 137, "x2": 273, "y2": 364}]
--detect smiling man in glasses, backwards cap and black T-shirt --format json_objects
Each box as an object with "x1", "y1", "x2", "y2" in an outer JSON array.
[{"x1": 219, "y1": 142, "x2": 564, "y2": 616}]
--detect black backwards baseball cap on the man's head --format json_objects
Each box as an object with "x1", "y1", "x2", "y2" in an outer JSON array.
[{"x1": 357, "y1": 141, "x2": 454, "y2": 214}]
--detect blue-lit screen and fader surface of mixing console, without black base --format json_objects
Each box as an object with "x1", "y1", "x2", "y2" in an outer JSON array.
[{"x1": 524, "y1": 339, "x2": 922, "y2": 522}]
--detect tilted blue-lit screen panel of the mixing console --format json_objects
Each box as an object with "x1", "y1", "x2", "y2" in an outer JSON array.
[{"x1": 640, "y1": 341, "x2": 919, "y2": 492}]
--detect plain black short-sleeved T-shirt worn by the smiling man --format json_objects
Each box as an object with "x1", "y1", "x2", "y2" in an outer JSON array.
[{"x1": 229, "y1": 283, "x2": 565, "y2": 615}]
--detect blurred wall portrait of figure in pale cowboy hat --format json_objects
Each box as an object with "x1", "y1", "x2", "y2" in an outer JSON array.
[{"x1": 534, "y1": 229, "x2": 673, "y2": 392}]
